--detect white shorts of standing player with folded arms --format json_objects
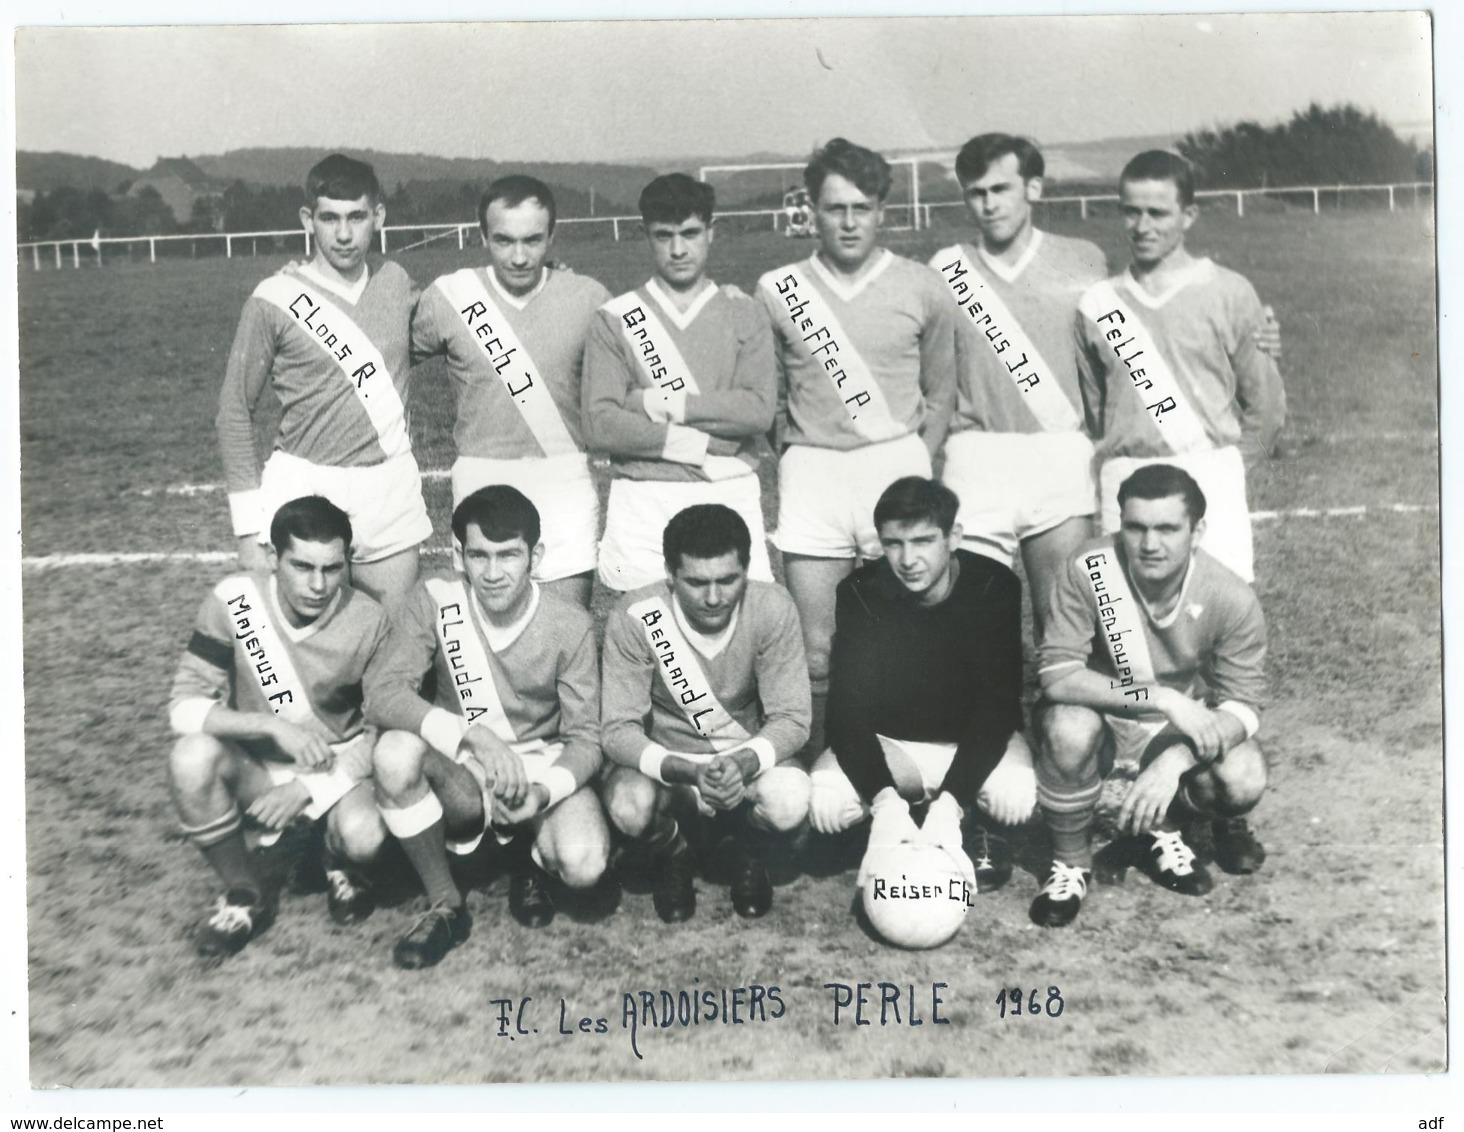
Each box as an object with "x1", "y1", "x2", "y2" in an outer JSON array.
[{"x1": 599, "y1": 474, "x2": 773, "y2": 593}]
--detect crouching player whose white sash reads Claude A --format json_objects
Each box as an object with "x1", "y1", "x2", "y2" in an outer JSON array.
[{"x1": 366, "y1": 483, "x2": 609, "y2": 968}]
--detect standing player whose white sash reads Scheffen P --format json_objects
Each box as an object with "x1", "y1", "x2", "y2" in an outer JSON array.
[{"x1": 757, "y1": 138, "x2": 956, "y2": 753}]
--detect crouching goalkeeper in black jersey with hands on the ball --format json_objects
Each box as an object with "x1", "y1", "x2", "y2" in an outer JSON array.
[{"x1": 811, "y1": 476, "x2": 1037, "y2": 892}]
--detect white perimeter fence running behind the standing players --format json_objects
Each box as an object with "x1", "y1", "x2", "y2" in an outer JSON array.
[{"x1": 18, "y1": 182, "x2": 1433, "y2": 271}]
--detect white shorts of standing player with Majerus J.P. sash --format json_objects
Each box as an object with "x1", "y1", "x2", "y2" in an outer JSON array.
[{"x1": 940, "y1": 429, "x2": 1098, "y2": 567}]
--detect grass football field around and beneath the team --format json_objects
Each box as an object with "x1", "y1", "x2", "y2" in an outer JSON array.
[{"x1": 19, "y1": 206, "x2": 1445, "y2": 1087}]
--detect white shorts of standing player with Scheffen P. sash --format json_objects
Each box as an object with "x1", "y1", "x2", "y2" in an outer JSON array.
[{"x1": 773, "y1": 432, "x2": 930, "y2": 558}]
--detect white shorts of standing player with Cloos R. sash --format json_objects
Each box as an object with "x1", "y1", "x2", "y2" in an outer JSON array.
[{"x1": 259, "y1": 451, "x2": 432, "y2": 562}]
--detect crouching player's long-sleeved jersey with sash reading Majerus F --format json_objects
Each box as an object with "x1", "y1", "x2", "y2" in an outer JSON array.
[{"x1": 168, "y1": 573, "x2": 388, "y2": 747}]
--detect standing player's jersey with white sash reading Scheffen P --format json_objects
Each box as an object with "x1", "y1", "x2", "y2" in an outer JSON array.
[{"x1": 757, "y1": 250, "x2": 956, "y2": 450}]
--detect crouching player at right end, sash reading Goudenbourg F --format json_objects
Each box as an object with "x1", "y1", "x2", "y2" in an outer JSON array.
[{"x1": 1032, "y1": 464, "x2": 1266, "y2": 927}]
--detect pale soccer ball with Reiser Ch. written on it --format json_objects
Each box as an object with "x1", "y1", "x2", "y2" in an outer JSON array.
[{"x1": 859, "y1": 842, "x2": 975, "y2": 949}]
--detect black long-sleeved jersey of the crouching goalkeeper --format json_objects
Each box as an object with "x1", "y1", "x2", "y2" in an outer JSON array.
[{"x1": 827, "y1": 551, "x2": 1022, "y2": 805}]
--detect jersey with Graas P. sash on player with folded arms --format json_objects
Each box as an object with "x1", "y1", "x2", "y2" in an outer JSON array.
[{"x1": 584, "y1": 280, "x2": 777, "y2": 482}]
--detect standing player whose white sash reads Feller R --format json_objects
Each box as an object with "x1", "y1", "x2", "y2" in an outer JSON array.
[{"x1": 1076, "y1": 149, "x2": 1285, "y2": 581}]
